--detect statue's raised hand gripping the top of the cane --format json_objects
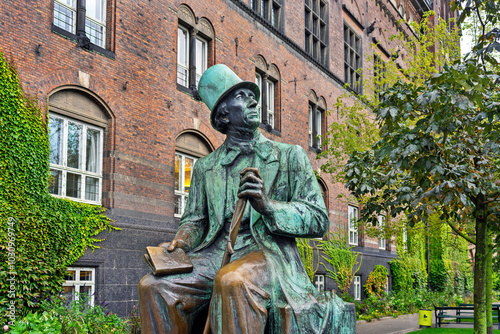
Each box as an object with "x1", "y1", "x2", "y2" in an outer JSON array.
[{"x1": 238, "y1": 167, "x2": 273, "y2": 216}]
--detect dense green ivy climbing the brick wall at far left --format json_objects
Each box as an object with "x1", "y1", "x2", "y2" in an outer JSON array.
[{"x1": 0, "y1": 52, "x2": 115, "y2": 324}]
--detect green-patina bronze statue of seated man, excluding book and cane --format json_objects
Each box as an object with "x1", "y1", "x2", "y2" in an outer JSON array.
[{"x1": 139, "y1": 65, "x2": 356, "y2": 334}]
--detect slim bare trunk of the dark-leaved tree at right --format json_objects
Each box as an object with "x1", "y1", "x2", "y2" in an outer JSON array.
[{"x1": 474, "y1": 194, "x2": 488, "y2": 334}]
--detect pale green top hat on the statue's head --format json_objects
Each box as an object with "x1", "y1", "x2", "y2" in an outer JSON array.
[{"x1": 198, "y1": 64, "x2": 260, "y2": 130}]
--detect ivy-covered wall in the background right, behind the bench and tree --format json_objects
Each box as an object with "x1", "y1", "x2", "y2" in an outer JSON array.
[{"x1": 390, "y1": 214, "x2": 474, "y2": 296}]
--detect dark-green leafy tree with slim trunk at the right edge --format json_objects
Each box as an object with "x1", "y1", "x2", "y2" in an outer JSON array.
[{"x1": 344, "y1": 0, "x2": 500, "y2": 334}]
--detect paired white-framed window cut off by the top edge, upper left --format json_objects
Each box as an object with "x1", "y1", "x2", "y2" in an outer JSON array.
[{"x1": 54, "y1": 0, "x2": 106, "y2": 48}]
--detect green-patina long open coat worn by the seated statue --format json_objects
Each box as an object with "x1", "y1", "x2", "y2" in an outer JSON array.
[{"x1": 177, "y1": 135, "x2": 355, "y2": 334}]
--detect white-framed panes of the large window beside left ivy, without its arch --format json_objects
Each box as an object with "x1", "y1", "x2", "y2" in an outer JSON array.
[{"x1": 49, "y1": 114, "x2": 103, "y2": 204}]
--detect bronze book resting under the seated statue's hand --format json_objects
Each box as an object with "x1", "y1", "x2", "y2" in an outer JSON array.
[{"x1": 144, "y1": 246, "x2": 193, "y2": 276}]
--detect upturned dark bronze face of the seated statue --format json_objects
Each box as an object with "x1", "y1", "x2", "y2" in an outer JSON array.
[{"x1": 225, "y1": 88, "x2": 260, "y2": 129}]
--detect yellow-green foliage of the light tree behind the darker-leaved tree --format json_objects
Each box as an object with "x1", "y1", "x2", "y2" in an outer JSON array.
[{"x1": 319, "y1": 11, "x2": 460, "y2": 239}]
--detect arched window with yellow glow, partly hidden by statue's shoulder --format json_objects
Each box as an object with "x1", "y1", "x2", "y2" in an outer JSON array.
[{"x1": 174, "y1": 131, "x2": 214, "y2": 217}]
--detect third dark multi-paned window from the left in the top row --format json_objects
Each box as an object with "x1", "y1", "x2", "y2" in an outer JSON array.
[{"x1": 344, "y1": 24, "x2": 362, "y2": 94}]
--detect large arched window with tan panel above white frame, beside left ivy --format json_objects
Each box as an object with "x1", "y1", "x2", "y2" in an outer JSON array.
[{"x1": 48, "y1": 88, "x2": 109, "y2": 204}]
